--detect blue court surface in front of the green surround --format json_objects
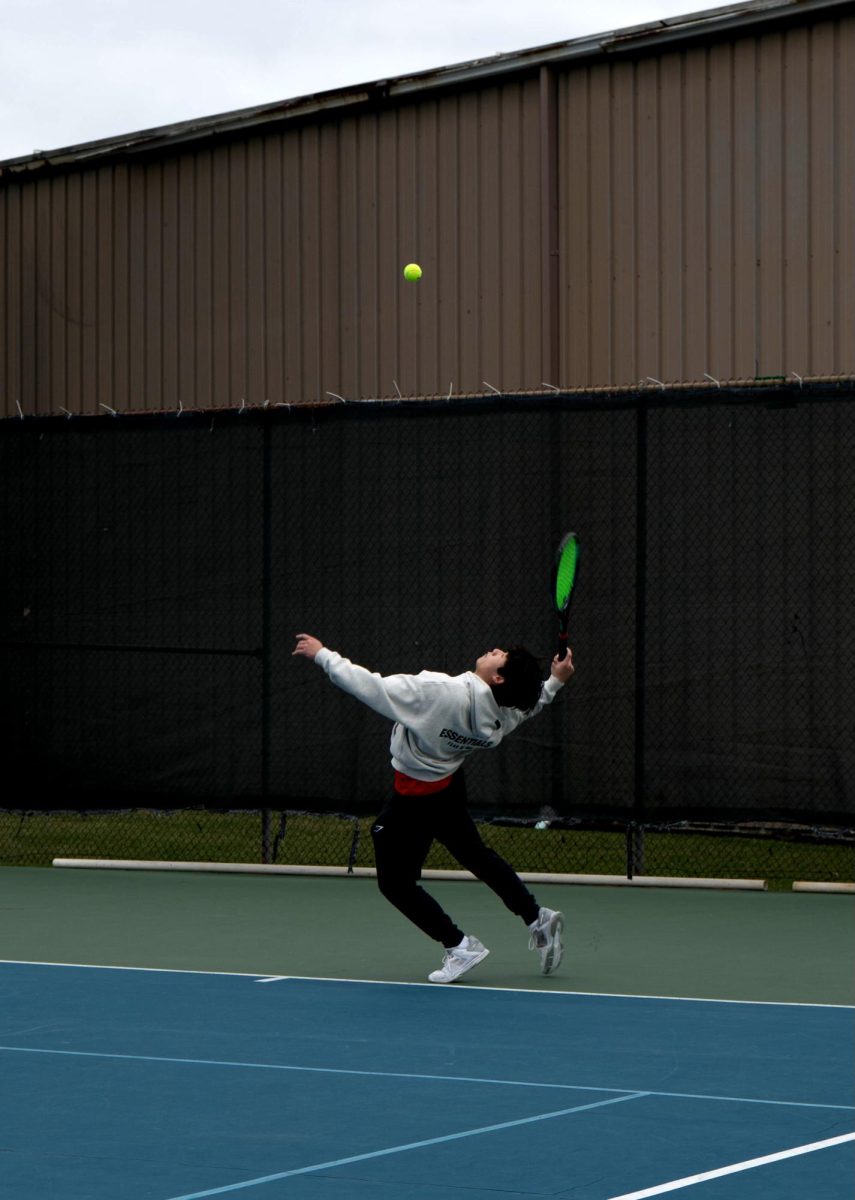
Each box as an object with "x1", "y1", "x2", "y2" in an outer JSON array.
[{"x1": 0, "y1": 962, "x2": 855, "y2": 1200}]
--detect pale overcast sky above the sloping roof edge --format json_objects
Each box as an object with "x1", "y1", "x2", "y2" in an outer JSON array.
[{"x1": 0, "y1": 0, "x2": 723, "y2": 161}]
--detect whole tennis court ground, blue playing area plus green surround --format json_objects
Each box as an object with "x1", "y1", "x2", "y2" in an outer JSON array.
[{"x1": 0, "y1": 869, "x2": 855, "y2": 1200}]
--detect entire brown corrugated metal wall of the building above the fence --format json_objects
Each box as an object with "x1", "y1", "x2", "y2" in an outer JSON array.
[{"x1": 0, "y1": 8, "x2": 855, "y2": 415}]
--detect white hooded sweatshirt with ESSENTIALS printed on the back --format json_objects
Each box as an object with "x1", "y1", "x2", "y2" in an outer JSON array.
[{"x1": 315, "y1": 647, "x2": 562, "y2": 782}]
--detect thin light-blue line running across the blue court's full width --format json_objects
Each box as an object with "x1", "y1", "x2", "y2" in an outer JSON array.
[{"x1": 0, "y1": 1045, "x2": 855, "y2": 1112}]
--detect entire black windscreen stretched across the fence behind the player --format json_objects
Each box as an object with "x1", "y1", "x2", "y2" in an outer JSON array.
[{"x1": 0, "y1": 389, "x2": 855, "y2": 823}]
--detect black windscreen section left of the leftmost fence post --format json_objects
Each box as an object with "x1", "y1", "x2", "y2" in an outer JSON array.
[{"x1": 0, "y1": 418, "x2": 263, "y2": 804}]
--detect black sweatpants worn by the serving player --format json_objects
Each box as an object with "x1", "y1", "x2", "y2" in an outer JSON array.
[{"x1": 371, "y1": 769, "x2": 538, "y2": 948}]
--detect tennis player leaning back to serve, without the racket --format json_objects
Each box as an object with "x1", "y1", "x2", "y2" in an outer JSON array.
[{"x1": 293, "y1": 634, "x2": 574, "y2": 983}]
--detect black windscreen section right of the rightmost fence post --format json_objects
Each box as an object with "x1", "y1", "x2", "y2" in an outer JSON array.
[{"x1": 645, "y1": 402, "x2": 855, "y2": 822}]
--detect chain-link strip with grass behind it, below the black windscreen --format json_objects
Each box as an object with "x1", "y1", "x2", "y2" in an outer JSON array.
[{"x1": 0, "y1": 810, "x2": 855, "y2": 888}]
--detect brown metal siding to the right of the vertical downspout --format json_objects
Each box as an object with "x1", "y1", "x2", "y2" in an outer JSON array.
[{"x1": 560, "y1": 19, "x2": 855, "y2": 386}]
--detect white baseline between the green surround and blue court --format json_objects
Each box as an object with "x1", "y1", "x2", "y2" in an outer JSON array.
[{"x1": 0, "y1": 959, "x2": 855, "y2": 1009}]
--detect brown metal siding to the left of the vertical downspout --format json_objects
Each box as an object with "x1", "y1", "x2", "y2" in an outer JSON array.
[{"x1": 0, "y1": 80, "x2": 540, "y2": 415}]
